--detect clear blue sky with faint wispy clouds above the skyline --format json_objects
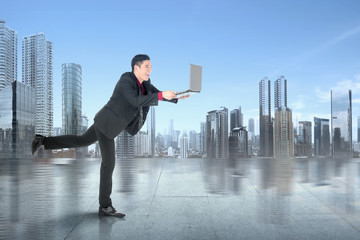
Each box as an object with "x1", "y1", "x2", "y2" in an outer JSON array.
[{"x1": 0, "y1": 0, "x2": 360, "y2": 139}]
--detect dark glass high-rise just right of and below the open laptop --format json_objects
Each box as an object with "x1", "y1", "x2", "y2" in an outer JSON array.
[{"x1": 206, "y1": 107, "x2": 229, "y2": 159}]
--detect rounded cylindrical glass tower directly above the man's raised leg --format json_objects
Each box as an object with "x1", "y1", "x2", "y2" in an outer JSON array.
[{"x1": 62, "y1": 63, "x2": 82, "y2": 135}]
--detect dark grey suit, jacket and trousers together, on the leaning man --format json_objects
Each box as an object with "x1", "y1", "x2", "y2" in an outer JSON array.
[{"x1": 43, "y1": 72, "x2": 177, "y2": 207}]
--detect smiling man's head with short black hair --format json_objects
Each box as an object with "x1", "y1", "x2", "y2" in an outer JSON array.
[{"x1": 131, "y1": 54, "x2": 151, "y2": 83}]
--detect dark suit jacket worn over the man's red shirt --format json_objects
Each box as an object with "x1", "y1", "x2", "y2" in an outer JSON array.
[{"x1": 94, "y1": 72, "x2": 177, "y2": 139}]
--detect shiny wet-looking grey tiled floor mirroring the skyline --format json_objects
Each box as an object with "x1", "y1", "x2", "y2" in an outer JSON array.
[{"x1": 0, "y1": 158, "x2": 360, "y2": 239}]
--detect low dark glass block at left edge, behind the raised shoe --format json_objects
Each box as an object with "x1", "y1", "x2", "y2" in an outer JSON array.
[{"x1": 0, "y1": 81, "x2": 35, "y2": 158}]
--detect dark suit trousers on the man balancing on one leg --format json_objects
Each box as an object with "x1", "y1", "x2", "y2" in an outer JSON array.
[{"x1": 43, "y1": 125, "x2": 115, "y2": 207}]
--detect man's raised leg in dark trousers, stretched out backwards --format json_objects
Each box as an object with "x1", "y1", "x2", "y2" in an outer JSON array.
[{"x1": 42, "y1": 125, "x2": 97, "y2": 149}]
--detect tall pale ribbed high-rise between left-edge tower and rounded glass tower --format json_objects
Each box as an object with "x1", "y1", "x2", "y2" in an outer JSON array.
[{"x1": 22, "y1": 32, "x2": 53, "y2": 136}]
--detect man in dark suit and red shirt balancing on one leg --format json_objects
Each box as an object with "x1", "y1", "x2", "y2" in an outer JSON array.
[{"x1": 32, "y1": 54, "x2": 186, "y2": 218}]
